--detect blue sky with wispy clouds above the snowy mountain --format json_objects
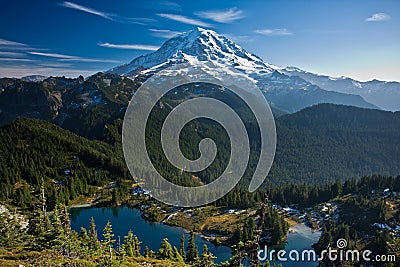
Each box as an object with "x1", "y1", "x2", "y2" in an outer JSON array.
[{"x1": 0, "y1": 0, "x2": 400, "y2": 81}]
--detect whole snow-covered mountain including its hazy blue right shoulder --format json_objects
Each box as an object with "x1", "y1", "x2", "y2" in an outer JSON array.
[{"x1": 108, "y1": 27, "x2": 377, "y2": 113}]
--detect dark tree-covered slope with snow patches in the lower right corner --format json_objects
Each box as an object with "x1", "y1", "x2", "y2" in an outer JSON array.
[{"x1": 314, "y1": 175, "x2": 400, "y2": 266}]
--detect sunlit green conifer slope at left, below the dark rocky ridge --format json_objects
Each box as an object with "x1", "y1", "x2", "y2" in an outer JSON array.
[{"x1": 0, "y1": 119, "x2": 129, "y2": 209}]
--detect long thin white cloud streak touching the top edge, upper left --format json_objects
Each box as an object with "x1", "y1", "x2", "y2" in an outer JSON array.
[{"x1": 60, "y1": 1, "x2": 154, "y2": 25}]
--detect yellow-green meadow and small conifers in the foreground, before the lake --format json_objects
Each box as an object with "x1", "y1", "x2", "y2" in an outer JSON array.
[{"x1": 0, "y1": 197, "x2": 287, "y2": 267}]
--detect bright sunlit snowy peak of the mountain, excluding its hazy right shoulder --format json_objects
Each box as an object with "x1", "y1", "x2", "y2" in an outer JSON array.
[{"x1": 109, "y1": 27, "x2": 277, "y2": 76}]
